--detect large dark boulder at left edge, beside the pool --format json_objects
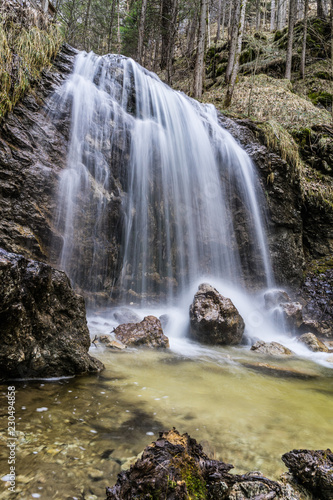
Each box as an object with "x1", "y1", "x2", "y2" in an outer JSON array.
[{"x1": 0, "y1": 249, "x2": 103, "y2": 378}]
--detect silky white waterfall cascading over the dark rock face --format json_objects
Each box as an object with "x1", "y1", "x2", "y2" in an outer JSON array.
[{"x1": 50, "y1": 52, "x2": 273, "y2": 303}]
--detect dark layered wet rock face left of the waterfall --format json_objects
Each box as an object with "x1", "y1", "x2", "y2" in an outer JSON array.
[{"x1": 0, "y1": 47, "x2": 76, "y2": 268}]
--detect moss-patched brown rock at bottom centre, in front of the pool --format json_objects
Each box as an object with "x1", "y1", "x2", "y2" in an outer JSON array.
[{"x1": 106, "y1": 429, "x2": 301, "y2": 500}]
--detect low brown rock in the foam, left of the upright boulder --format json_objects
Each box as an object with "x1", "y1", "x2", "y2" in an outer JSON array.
[{"x1": 114, "y1": 316, "x2": 169, "y2": 348}]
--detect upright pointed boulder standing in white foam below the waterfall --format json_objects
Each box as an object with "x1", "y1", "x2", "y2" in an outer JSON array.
[{"x1": 190, "y1": 283, "x2": 245, "y2": 345}]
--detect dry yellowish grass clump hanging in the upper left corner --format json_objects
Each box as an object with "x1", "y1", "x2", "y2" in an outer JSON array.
[{"x1": 0, "y1": 5, "x2": 62, "y2": 121}]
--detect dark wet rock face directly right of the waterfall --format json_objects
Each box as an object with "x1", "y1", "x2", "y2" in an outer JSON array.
[{"x1": 219, "y1": 116, "x2": 306, "y2": 288}]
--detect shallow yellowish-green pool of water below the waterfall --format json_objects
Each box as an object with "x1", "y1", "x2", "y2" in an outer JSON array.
[{"x1": 0, "y1": 348, "x2": 333, "y2": 500}]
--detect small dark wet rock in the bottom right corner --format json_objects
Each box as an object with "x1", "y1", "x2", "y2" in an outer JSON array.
[{"x1": 282, "y1": 449, "x2": 333, "y2": 500}]
